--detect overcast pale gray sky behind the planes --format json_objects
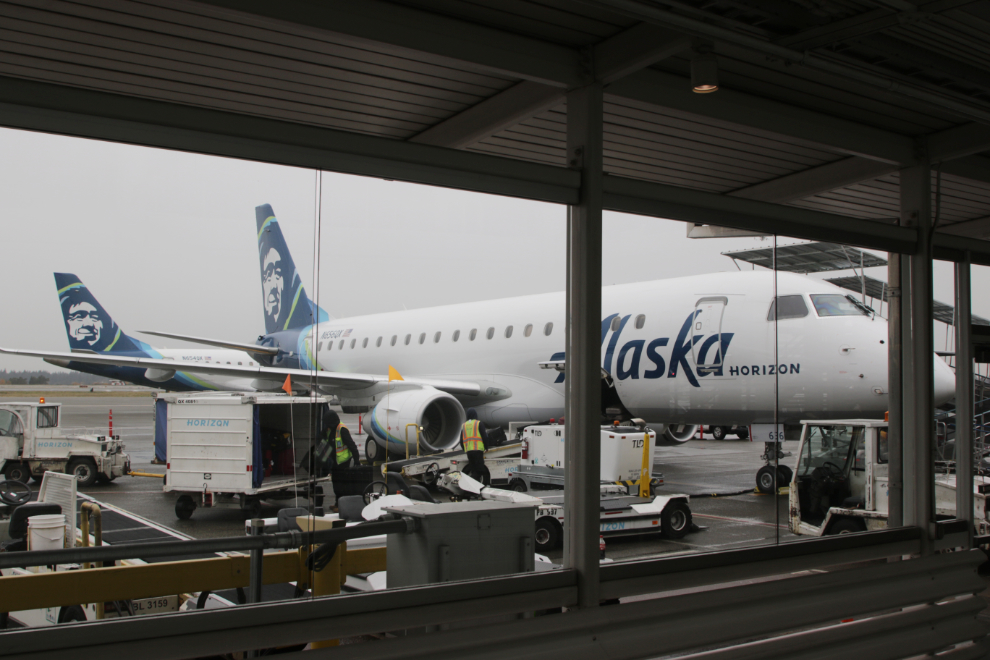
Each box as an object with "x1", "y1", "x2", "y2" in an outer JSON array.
[{"x1": 0, "y1": 129, "x2": 990, "y2": 369}]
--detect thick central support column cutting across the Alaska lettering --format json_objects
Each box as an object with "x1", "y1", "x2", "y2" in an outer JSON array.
[{"x1": 564, "y1": 84, "x2": 602, "y2": 608}]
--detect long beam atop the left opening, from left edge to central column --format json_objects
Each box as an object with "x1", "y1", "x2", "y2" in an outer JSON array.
[{"x1": 0, "y1": 77, "x2": 581, "y2": 204}]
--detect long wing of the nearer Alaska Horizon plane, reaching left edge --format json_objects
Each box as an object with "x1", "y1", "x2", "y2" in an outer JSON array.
[{"x1": 0, "y1": 348, "x2": 481, "y2": 397}]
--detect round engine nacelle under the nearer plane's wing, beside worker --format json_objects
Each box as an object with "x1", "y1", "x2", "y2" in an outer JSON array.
[{"x1": 367, "y1": 387, "x2": 467, "y2": 456}]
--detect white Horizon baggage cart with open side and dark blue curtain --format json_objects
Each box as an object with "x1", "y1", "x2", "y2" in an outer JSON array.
[{"x1": 158, "y1": 392, "x2": 331, "y2": 520}]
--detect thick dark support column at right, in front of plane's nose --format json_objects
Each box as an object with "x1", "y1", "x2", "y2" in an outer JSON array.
[{"x1": 900, "y1": 159, "x2": 935, "y2": 554}]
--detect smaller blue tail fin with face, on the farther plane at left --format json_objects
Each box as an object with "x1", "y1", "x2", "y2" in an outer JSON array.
[{"x1": 55, "y1": 273, "x2": 140, "y2": 353}]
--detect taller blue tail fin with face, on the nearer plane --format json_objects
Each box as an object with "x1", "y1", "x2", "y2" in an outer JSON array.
[{"x1": 255, "y1": 204, "x2": 330, "y2": 334}]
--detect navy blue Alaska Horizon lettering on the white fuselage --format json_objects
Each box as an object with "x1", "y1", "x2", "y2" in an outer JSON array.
[{"x1": 550, "y1": 310, "x2": 801, "y2": 387}]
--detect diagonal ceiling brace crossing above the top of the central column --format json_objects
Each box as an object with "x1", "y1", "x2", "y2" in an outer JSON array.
[{"x1": 409, "y1": 23, "x2": 691, "y2": 149}]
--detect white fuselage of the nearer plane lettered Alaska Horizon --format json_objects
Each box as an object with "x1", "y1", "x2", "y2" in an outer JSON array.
[{"x1": 298, "y1": 271, "x2": 954, "y2": 425}]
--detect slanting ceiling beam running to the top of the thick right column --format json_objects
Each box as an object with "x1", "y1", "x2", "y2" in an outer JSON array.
[{"x1": 728, "y1": 156, "x2": 897, "y2": 204}]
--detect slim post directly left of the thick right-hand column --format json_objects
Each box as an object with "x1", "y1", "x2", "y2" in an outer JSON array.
[{"x1": 887, "y1": 252, "x2": 904, "y2": 527}]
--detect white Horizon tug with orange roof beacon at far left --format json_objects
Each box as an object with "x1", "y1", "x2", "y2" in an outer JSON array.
[{"x1": 0, "y1": 398, "x2": 131, "y2": 487}]
